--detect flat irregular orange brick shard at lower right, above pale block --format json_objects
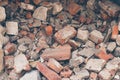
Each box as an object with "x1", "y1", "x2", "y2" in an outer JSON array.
[{"x1": 96, "y1": 50, "x2": 113, "y2": 61}]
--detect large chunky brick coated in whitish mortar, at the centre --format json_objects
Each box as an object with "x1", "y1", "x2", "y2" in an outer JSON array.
[{"x1": 55, "y1": 25, "x2": 76, "y2": 44}]
